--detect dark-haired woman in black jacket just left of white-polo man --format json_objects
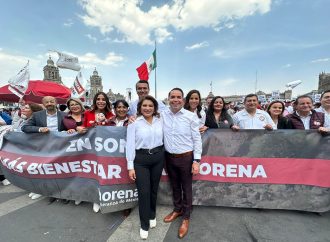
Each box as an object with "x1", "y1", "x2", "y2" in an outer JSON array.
[{"x1": 205, "y1": 96, "x2": 234, "y2": 129}]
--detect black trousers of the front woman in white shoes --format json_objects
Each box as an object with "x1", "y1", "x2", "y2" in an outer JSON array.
[{"x1": 134, "y1": 150, "x2": 165, "y2": 231}]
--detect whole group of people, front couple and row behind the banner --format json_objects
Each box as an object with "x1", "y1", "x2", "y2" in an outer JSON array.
[{"x1": 0, "y1": 80, "x2": 330, "y2": 239}]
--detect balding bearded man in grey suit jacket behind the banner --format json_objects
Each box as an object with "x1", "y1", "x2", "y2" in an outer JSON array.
[{"x1": 22, "y1": 96, "x2": 66, "y2": 133}]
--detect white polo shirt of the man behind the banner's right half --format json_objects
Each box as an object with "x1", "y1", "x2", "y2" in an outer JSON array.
[{"x1": 233, "y1": 109, "x2": 277, "y2": 129}]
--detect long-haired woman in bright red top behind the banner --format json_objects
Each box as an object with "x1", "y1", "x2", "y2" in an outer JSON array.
[{"x1": 77, "y1": 92, "x2": 114, "y2": 134}]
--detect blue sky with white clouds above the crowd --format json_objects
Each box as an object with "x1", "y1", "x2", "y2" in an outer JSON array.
[{"x1": 0, "y1": 0, "x2": 330, "y2": 98}]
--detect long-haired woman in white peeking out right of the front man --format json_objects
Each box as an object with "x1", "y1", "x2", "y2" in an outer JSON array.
[{"x1": 184, "y1": 90, "x2": 207, "y2": 133}]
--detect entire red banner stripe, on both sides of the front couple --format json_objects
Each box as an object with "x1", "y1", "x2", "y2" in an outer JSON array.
[{"x1": 1, "y1": 151, "x2": 330, "y2": 187}]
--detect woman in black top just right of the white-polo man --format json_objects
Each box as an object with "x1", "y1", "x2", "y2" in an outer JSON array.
[{"x1": 267, "y1": 100, "x2": 292, "y2": 129}]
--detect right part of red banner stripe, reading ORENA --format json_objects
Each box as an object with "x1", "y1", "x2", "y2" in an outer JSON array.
[{"x1": 194, "y1": 156, "x2": 330, "y2": 187}]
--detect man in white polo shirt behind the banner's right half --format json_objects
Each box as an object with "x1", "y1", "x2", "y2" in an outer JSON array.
[{"x1": 232, "y1": 94, "x2": 277, "y2": 130}]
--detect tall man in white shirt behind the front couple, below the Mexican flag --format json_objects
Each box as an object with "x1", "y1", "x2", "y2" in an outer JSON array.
[{"x1": 128, "y1": 80, "x2": 166, "y2": 116}]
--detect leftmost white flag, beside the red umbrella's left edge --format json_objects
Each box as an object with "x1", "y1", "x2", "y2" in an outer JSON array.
[{"x1": 8, "y1": 62, "x2": 30, "y2": 98}]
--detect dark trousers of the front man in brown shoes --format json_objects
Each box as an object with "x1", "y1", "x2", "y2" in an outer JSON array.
[{"x1": 165, "y1": 152, "x2": 193, "y2": 219}]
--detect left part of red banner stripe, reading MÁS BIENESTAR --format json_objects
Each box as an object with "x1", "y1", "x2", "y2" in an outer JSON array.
[{"x1": 1, "y1": 151, "x2": 132, "y2": 185}]
